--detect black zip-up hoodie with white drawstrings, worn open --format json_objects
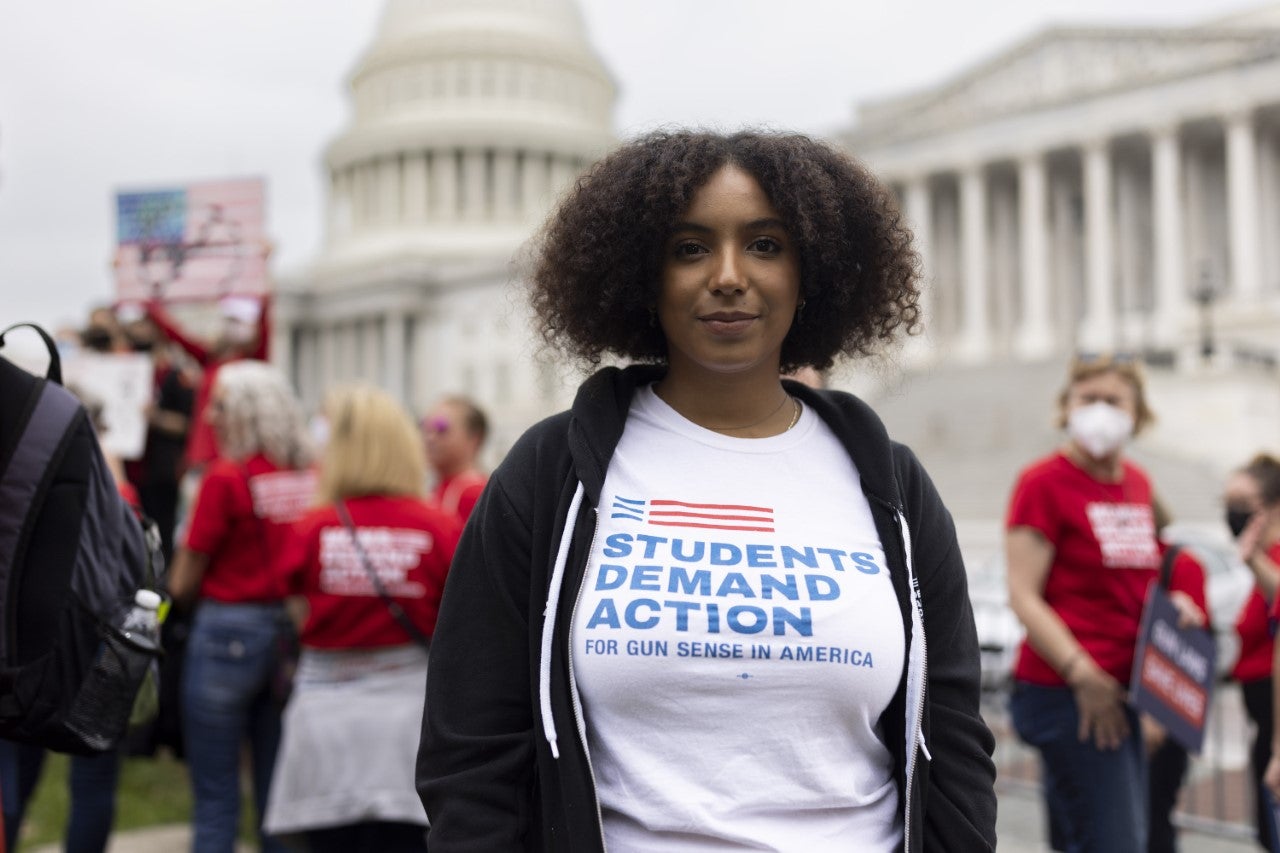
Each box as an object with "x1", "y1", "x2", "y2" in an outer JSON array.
[{"x1": 417, "y1": 366, "x2": 996, "y2": 853}]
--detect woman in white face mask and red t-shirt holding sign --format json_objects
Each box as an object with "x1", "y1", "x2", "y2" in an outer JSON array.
[{"x1": 1005, "y1": 353, "x2": 1204, "y2": 853}]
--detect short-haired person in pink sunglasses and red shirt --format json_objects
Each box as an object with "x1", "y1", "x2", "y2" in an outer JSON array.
[{"x1": 422, "y1": 397, "x2": 489, "y2": 524}]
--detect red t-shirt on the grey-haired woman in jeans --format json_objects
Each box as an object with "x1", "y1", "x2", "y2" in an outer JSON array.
[{"x1": 187, "y1": 455, "x2": 316, "y2": 603}]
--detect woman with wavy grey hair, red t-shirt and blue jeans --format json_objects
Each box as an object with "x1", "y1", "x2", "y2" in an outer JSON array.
[{"x1": 168, "y1": 360, "x2": 315, "y2": 850}]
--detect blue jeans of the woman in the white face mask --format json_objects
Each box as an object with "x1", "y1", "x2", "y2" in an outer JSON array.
[{"x1": 1009, "y1": 681, "x2": 1147, "y2": 853}]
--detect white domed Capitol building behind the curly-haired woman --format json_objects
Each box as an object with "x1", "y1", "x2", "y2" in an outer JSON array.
[{"x1": 273, "y1": 0, "x2": 616, "y2": 452}]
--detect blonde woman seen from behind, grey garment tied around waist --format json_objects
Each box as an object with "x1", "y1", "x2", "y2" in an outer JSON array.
[{"x1": 266, "y1": 386, "x2": 461, "y2": 853}]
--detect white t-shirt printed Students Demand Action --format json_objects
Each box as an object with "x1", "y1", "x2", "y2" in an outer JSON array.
[{"x1": 571, "y1": 388, "x2": 905, "y2": 853}]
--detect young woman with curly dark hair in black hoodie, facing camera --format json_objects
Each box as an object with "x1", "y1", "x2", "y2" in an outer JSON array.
[{"x1": 417, "y1": 132, "x2": 996, "y2": 853}]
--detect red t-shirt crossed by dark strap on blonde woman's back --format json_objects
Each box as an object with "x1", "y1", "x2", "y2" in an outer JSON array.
[{"x1": 280, "y1": 496, "x2": 461, "y2": 648}]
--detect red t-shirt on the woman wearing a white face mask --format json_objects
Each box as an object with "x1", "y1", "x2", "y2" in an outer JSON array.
[{"x1": 1006, "y1": 453, "x2": 1160, "y2": 686}]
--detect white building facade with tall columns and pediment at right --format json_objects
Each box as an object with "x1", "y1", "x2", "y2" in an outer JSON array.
[{"x1": 842, "y1": 6, "x2": 1280, "y2": 364}]
